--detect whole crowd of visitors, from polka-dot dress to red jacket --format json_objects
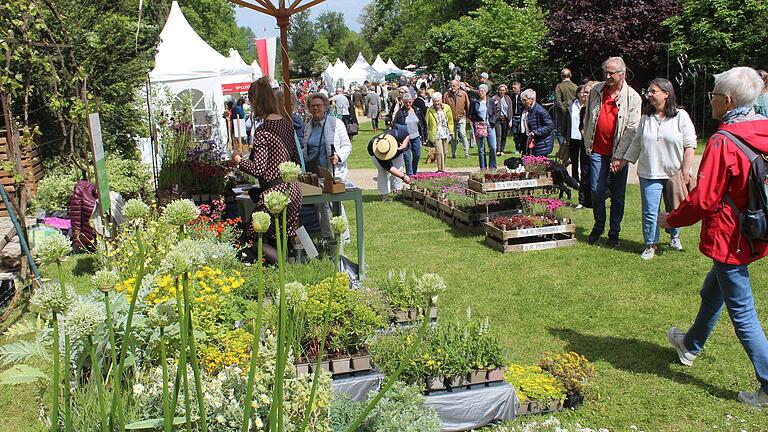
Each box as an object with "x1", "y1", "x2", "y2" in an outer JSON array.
[{"x1": 226, "y1": 57, "x2": 768, "y2": 406}]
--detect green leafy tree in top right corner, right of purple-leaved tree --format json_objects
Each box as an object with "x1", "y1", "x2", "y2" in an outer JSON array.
[{"x1": 664, "y1": 0, "x2": 768, "y2": 71}]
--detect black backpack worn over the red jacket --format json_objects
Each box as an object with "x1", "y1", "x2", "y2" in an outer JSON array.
[{"x1": 718, "y1": 130, "x2": 768, "y2": 253}]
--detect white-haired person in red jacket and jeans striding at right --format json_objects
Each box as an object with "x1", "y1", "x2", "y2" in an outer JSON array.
[{"x1": 660, "y1": 67, "x2": 768, "y2": 407}]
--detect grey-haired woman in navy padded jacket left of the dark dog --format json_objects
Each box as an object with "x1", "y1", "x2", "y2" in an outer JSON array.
[{"x1": 520, "y1": 89, "x2": 555, "y2": 156}]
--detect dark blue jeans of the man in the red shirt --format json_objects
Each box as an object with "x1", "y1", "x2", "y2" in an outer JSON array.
[{"x1": 591, "y1": 153, "x2": 629, "y2": 237}]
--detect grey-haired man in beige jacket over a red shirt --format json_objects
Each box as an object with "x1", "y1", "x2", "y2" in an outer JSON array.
[{"x1": 582, "y1": 57, "x2": 642, "y2": 246}]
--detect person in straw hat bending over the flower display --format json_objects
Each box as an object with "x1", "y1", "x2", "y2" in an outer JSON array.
[{"x1": 368, "y1": 125, "x2": 411, "y2": 201}]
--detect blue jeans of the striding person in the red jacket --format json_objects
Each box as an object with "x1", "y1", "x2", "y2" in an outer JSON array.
[{"x1": 683, "y1": 261, "x2": 768, "y2": 392}]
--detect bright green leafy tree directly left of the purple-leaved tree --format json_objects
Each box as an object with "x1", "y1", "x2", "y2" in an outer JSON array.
[{"x1": 425, "y1": 0, "x2": 547, "y2": 87}]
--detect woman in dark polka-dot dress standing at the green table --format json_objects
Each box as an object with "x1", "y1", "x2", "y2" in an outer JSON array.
[{"x1": 232, "y1": 76, "x2": 301, "y2": 262}]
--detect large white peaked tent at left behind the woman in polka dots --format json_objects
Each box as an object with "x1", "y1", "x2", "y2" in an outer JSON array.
[{"x1": 149, "y1": 1, "x2": 254, "y2": 142}]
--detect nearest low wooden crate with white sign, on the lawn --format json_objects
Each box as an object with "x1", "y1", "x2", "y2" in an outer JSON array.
[{"x1": 483, "y1": 222, "x2": 576, "y2": 253}]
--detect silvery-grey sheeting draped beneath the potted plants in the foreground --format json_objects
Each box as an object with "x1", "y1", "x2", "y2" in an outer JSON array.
[{"x1": 332, "y1": 372, "x2": 520, "y2": 432}]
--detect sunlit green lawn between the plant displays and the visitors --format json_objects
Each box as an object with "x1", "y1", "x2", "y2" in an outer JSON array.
[{"x1": 0, "y1": 185, "x2": 768, "y2": 432}]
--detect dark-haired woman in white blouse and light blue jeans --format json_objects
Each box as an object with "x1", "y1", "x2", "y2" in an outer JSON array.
[{"x1": 621, "y1": 78, "x2": 696, "y2": 260}]
